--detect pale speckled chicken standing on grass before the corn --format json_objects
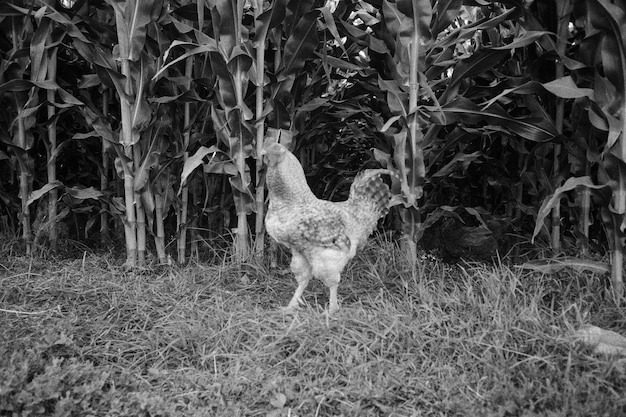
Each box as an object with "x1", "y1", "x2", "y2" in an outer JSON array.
[{"x1": 263, "y1": 143, "x2": 393, "y2": 314}]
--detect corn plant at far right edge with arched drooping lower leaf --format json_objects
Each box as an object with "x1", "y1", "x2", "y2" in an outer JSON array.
[{"x1": 533, "y1": 0, "x2": 626, "y2": 299}]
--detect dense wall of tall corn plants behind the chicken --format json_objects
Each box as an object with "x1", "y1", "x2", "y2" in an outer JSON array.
[{"x1": 0, "y1": 0, "x2": 626, "y2": 282}]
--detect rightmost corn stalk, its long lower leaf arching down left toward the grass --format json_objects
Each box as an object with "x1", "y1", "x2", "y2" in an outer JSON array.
[{"x1": 533, "y1": 0, "x2": 626, "y2": 301}]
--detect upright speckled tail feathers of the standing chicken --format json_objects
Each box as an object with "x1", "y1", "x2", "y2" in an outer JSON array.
[{"x1": 349, "y1": 169, "x2": 396, "y2": 221}]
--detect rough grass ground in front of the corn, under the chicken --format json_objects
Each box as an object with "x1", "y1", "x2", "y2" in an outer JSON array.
[{"x1": 0, "y1": 239, "x2": 626, "y2": 416}]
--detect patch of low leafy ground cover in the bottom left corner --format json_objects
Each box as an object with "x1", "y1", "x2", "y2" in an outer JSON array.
[{"x1": 0, "y1": 344, "x2": 219, "y2": 417}]
